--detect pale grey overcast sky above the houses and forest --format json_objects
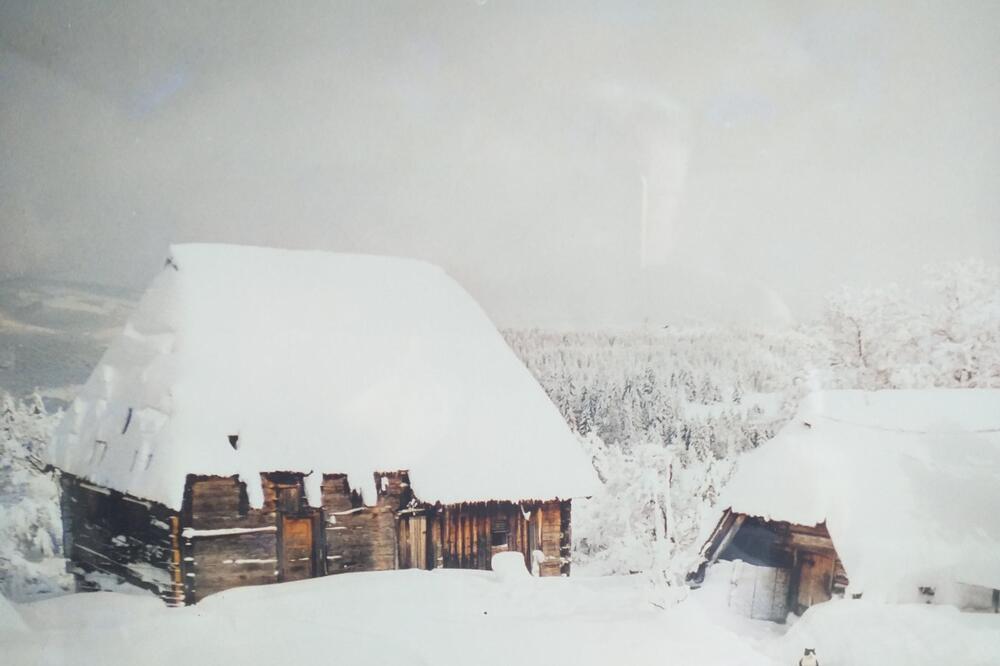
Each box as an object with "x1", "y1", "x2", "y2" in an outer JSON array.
[{"x1": 0, "y1": 0, "x2": 1000, "y2": 326}]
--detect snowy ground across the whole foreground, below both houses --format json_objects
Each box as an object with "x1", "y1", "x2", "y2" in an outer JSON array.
[{"x1": 0, "y1": 570, "x2": 1000, "y2": 666}]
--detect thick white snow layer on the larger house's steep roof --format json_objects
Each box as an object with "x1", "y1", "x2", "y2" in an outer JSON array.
[{"x1": 48, "y1": 245, "x2": 597, "y2": 508}]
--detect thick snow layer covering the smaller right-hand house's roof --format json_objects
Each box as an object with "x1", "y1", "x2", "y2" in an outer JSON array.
[{"x1": 722, "y1": 389, "x2": 1000, "y2": 600}]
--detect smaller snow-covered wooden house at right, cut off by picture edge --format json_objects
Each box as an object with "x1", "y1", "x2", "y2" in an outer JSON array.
[{"x1": 696, "y1": 389, "x2": 1000, "y2": 619}]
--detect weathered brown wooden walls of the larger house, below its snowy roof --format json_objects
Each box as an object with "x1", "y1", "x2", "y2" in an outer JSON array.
[{"x1": 63, "y1": 471, "x2": 570, "y2": 603}]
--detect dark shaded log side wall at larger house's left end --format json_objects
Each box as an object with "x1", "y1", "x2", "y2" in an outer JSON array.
[{"x1": 60, "y1": 474, "x2": 184, "y2": 605}]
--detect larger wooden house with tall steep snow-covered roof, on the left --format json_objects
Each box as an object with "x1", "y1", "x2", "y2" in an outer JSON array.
[{"x1": 47, "y1": 245, "x2": 596, "y2": 603}]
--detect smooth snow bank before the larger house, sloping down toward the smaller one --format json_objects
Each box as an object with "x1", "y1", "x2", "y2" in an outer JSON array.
[{"x1": 4, "y1": 570, "x2": 775, "y2": 666}]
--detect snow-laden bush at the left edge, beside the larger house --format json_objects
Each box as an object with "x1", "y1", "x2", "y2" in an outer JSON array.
[{"x1": 0, "y1": 392, "x2": 70, "y2": 601}]
